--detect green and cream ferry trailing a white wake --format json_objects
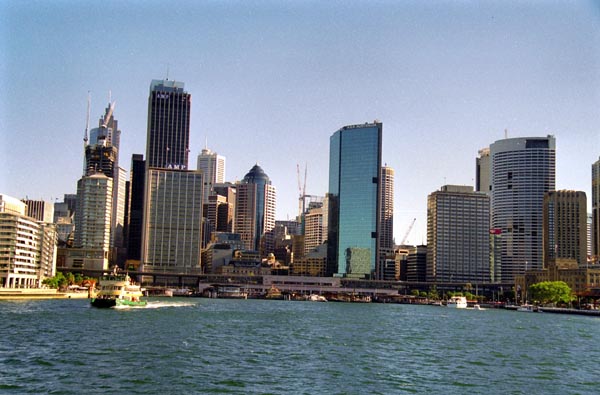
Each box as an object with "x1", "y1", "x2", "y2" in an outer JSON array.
[{"x1": 92, "y1": 268, "x2": 147, "y2": 308}]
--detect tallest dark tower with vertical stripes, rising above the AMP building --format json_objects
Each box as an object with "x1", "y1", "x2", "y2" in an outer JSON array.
[{"x1": 146, "y1": 80, "x2": 192, "y2": 170}]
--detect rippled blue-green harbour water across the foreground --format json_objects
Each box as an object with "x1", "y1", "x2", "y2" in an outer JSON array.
[{"x1": 0, "y1": 298, "x2": 600, "y2": 394}]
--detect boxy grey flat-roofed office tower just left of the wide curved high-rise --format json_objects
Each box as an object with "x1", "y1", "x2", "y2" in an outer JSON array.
[{"x1": 427, "y1": 185, "x2": 490, "y2": 283}]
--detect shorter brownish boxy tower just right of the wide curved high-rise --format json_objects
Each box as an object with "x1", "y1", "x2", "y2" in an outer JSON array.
[{"x1": 543, "y1": 191, "x2": 587, "y2": 266}]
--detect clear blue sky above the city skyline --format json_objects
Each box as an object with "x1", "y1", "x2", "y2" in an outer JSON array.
[{"x1": 0, "y1": 0, "x2": 600, "y2": 243}]
